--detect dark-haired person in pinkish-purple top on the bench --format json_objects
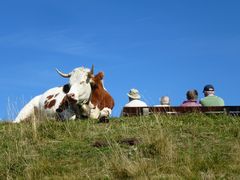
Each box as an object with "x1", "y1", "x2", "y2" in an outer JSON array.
[{"x1": 180, "y1": 89, "x2": 202, "y2": 107}]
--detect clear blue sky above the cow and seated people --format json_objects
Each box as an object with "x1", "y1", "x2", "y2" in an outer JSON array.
[{"x1": 0, "y1": 0, "x2": 240, "y2": 118}]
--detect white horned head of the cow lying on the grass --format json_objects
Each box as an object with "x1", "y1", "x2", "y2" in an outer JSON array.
[{"x1": 56, "y1": 66, "x2": 93, "y2": 104}]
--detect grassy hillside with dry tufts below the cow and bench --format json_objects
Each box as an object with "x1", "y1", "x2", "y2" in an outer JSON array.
[{"x1": 0, "y1": 114, "x2": 240, "y2": 179}]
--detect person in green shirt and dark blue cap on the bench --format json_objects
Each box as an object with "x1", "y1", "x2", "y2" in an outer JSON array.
[{"x1": 200, "y1": 84, "x2": 224, "y2": 106}]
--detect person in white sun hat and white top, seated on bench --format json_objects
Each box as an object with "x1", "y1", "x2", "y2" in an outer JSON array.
[{"x1": 124, "y1": 88, "x2": 147, "y2": 107}]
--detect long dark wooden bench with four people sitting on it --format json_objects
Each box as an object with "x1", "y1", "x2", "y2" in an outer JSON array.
[{"x1": 122, "y1": 106, "x2": 240, "y2": 116}]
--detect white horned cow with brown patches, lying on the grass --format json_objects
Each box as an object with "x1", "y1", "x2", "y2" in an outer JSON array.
[{"x1": 13, "y1": 67, "x2": 93, "y2": 123}]
